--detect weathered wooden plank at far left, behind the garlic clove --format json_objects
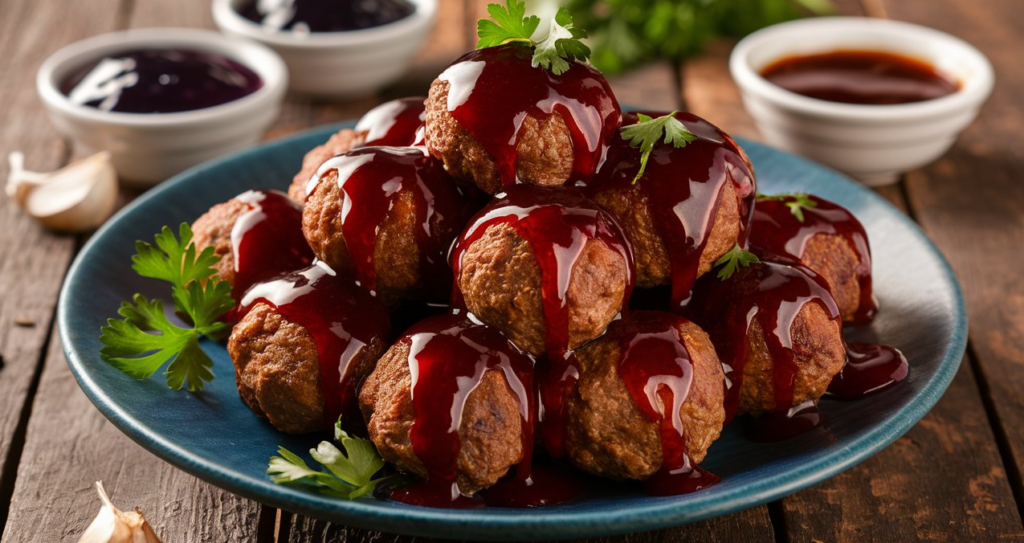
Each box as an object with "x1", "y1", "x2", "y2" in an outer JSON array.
[{"x1": 0, "y1": 0, "x2": 119, "y2": 527}]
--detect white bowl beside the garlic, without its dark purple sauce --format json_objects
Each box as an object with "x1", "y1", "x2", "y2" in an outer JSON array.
[{"x1": 36, "y1": 29, "x2": 288, "y2": 186}]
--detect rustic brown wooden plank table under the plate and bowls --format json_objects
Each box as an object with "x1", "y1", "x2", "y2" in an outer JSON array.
[{"x1": 0, "y1": 0, "x2": 1024, "y2": 543}]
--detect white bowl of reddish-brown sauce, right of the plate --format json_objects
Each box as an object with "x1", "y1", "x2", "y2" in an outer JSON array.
[{"x1": 729, "y1": 17, "x2": 994, "y2": 186}]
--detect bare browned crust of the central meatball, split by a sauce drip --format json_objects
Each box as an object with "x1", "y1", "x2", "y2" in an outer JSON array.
[{"x1": 457, "y1": 223, "x2": 629, "y2": 357}]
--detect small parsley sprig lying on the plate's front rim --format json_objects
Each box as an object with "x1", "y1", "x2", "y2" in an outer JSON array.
[{"x1": 266, "y1": 420, "x2": 393, "y2": 500}]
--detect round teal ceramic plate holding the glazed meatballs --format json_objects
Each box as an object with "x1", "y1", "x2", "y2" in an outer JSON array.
[{"x1": 58, "y1": 121, "x2": 967, "y2": 540}]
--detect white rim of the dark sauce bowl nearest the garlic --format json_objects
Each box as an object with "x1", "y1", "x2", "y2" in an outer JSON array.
[{"x1": 36, "y1": 28, "x2": 288, "y2": 128}]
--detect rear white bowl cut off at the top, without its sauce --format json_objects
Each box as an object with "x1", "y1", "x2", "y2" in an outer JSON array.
[{"x1": 213, "y1": 0, "x2": 437, "y2": 99}]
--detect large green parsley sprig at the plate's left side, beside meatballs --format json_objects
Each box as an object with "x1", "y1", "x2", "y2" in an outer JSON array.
[{"x1": 99, "y1": 223, "x2": 234, "y2": 392}]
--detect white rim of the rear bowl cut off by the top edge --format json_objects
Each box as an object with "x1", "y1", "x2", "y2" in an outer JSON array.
[{"x1": 213, "y1": 0, "x2": 437, "y2": 49}]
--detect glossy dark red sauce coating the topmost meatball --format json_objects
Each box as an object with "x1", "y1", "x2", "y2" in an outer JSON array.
[{"x1": 438, "y1": 45, "x2": 622, "y2": 186}]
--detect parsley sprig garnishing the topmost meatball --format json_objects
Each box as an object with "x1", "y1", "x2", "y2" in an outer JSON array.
[{"x1": 476, "y1": 0, "x2": 590, "y2": 76}]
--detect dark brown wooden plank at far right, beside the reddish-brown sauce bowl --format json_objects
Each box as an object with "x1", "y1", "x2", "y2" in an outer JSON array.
[{"x1": 884, "y1": 0, "x2": 1024, "y2": 514}]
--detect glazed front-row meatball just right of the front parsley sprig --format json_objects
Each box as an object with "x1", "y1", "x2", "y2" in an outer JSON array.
[{"x1": 359, "y1": 316, "x2": 534, "y2": 495}]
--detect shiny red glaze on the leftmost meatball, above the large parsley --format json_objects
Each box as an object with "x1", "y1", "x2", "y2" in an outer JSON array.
[{"x1": 231, "y1": 191, "x2": 313, "y2": 301}]
